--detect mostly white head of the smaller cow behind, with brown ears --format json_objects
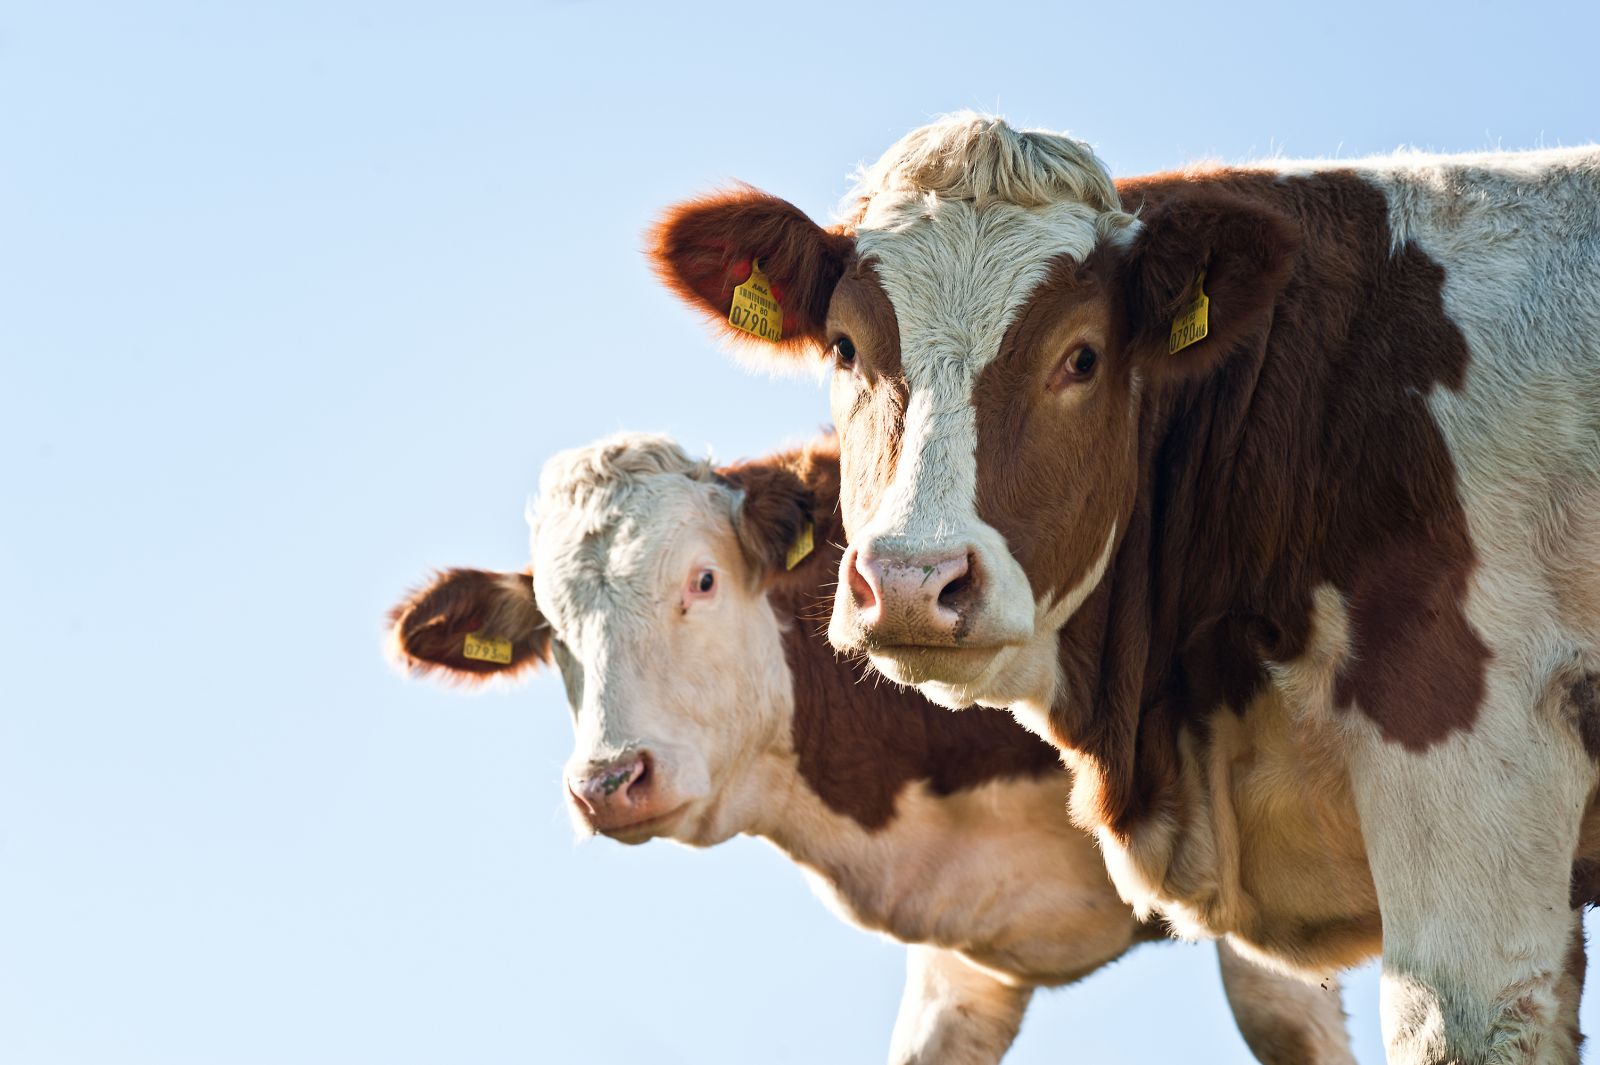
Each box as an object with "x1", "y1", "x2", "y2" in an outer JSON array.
[{"x1": 390, "y1": 435, "x2": 810, "y2": 846}]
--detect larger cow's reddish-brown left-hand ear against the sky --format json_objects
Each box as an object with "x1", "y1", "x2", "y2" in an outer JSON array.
[{"x1": 646, "y1": 187, "x2": 854, "y2": 361}]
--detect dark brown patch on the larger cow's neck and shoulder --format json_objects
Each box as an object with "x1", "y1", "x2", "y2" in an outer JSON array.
[{"x1": 1051, "y1": 171, "x2": 1488, "y2": 833}]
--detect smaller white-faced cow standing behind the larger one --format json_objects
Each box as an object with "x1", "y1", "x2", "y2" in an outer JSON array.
[{"x1": 380, "y1": 435, "x2": 1354, "y2": 1065}]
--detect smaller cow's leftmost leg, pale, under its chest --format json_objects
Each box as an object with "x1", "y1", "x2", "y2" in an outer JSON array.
[{"x1": 890, "y1": 943, "x2": 1034, "y2": 1065}]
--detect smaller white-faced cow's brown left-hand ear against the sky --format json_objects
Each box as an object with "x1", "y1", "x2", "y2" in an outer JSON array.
[{"x1": 389, "y1": 569, "x2": 550, "y2": 680}]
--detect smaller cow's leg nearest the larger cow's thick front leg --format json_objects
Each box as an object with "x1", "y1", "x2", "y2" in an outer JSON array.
[{"x1": 1216, "y1": 939, "x2": 1355, "y2": 1065}]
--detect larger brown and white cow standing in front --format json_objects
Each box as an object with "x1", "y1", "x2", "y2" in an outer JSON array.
[{"x1": 653, "y1": 115, "x2": 1600, "y2": 1065}]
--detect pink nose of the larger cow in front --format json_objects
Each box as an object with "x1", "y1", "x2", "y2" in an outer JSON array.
[{"x1": 850, "y1": 545, "x2": 978, "y2": 633}]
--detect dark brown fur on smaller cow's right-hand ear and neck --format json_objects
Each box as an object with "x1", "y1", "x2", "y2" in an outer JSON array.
[{"x1": 725, "y1": 437, "x2": 1067, "y2": 830}]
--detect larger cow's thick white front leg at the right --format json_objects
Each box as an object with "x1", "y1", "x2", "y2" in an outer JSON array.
[{"x1": 1350, "y1": 673, "x2": 1594, "y2": 1065}]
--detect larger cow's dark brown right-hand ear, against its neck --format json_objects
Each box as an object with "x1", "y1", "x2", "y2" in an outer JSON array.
[{"x1": 1126, "y1": 190, "x2": 1299, "y2": 379}]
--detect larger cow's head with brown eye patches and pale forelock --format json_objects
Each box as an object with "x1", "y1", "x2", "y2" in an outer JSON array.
[{"x1": 651, "y1": 115, "x2": 1294, "y2": 705}]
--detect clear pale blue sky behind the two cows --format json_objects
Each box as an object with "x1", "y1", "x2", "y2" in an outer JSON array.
[{"x1": 9, "y1": 0, "x2": 1600, "y2": 1065}]
